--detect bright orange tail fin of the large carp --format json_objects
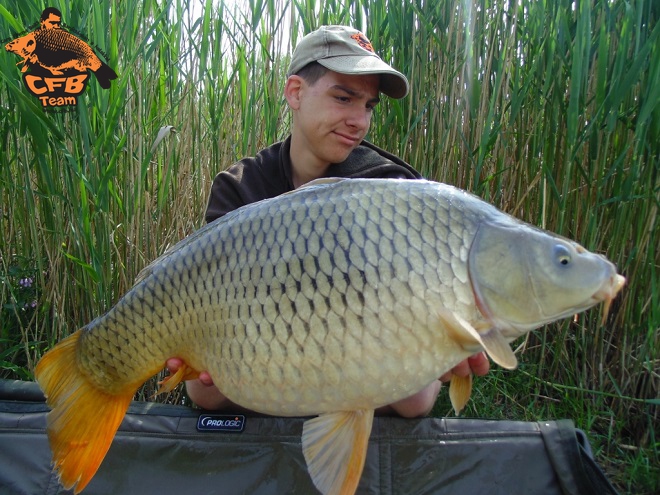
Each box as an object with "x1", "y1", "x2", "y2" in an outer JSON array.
[{"x1": 35, "y1": 330, "x2": 135, "y2": 494}]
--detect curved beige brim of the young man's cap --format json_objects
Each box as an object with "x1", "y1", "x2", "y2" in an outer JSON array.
[{"x1": 317, "y1": 55, "x2": 409, "y2": 99}]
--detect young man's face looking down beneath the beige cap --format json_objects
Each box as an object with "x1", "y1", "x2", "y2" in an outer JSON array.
[{"x1": 289, "y1": 71, "x2": 380, "y2": 170}]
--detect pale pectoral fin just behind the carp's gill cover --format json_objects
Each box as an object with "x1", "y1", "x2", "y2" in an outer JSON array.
[{"x1": 438, "y1": 310, "x2": 518, "y2": 370}]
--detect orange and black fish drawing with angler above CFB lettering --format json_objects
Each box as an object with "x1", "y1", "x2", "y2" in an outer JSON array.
[{"x1": 5, "y1": 7, "x2": 117, "y2": 89}]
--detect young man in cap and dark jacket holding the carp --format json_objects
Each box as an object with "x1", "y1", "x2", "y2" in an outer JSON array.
[{"x1": 167, "y1": 26, "x2": 489, "y2": 417}]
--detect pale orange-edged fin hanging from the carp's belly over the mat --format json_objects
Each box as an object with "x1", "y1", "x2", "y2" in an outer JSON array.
[{"x1": 302, "y1": 410, "x2": 374, "y2": 495}]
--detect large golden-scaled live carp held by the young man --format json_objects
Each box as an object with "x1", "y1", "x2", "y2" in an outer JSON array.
[{"x1": 36, "y1": 179, "x2": 625, "y2": 494}]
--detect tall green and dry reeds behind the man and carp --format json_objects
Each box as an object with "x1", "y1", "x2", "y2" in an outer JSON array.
[{"x1": 0, "y1": 0, "x2": 660, "y2": 494}]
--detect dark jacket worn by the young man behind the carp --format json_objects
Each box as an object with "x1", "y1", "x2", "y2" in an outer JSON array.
[{"x1": 205, "y1": 137, "x2": 422, "y2": 222}]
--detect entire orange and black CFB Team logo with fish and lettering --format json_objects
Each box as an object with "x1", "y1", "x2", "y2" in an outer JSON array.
[{"x1": 5, "y1": 7, "x2": 117, "y2": 111}]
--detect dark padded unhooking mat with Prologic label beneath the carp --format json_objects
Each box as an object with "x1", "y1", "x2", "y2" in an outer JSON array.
[{"x1": 0, "y1": 380, "x2": 616, "y2": 495}]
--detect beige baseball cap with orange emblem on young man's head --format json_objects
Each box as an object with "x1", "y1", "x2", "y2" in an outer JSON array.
[{"x1": 287, "y1": 26, "x2": 409, "y2": 98}]
